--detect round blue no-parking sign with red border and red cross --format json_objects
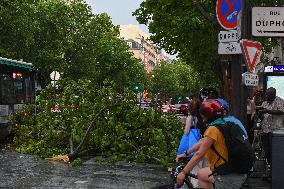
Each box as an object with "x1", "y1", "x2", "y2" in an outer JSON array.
[{"x1": 216, "y1": 0, "x2": 242, "y2": 30}]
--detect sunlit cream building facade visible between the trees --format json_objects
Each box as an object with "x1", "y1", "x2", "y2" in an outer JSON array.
[{"x1": 120, "y1": 25, "x2": 169, "y2": 73}]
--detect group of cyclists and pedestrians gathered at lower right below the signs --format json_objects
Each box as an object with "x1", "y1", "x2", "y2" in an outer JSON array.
[{"x1": 173, "y1": 87, "x2": 284, "y2": 189}]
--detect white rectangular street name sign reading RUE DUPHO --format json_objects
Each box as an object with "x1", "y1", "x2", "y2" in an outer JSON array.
[{"x1": 252, "y1": 7, "x2": 284, "y2": 37}]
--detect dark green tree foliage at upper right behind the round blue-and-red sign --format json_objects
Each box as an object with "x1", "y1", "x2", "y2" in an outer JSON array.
[{"x1": 133, "y1": 0, "x2": 276, "y2": 87}]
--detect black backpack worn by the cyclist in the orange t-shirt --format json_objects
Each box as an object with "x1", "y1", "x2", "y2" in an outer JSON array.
[{"x1": 211, "y1": 122, "x2": 255, "y2": 175}]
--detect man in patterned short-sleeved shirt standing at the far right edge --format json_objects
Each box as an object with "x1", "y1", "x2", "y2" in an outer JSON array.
[{"x1": 257, "y1": 87, "x2": 284, "y2": 172}]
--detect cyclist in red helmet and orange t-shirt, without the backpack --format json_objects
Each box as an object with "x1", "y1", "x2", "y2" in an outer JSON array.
[{"x1": 177, "y1": 100, "x2": 245, "y2": 189}]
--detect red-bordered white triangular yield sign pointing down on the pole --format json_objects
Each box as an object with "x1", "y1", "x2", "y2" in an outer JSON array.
[{"x1": 241, "y1": 39, "x2": 262, "y2": 73}]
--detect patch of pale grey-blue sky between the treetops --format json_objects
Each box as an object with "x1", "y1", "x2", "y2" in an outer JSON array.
[{"x1": 86, "y1": 0, "x2": 147, "y2": 31}]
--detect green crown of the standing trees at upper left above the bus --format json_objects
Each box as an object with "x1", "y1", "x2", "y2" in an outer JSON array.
[{"x1": 0, "y1": 0, "x2": 146, "y2": 88}]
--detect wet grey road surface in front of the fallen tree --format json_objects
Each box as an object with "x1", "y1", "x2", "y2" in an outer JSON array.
[{"x1": 0, "y1": 147, "x2": 170, "y2": 189}]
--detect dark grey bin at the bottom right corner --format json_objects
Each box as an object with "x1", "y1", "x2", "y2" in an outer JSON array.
[{"x1": 271, "y1": 128, "x2": 284, "y2": 189}]
